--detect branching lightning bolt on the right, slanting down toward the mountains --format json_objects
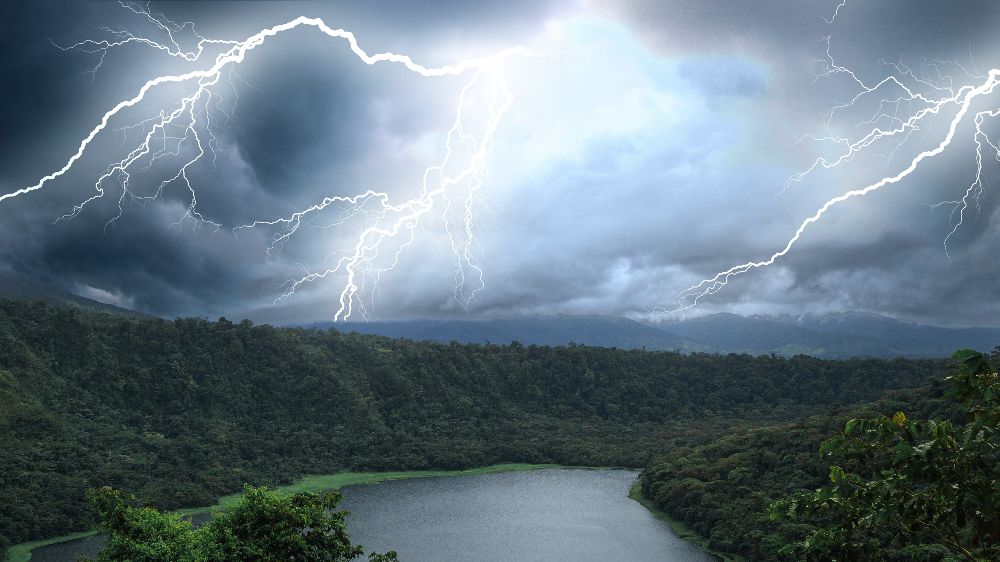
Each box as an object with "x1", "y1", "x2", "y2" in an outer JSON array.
[{"x1": 653, "y1": 39, "x2": 1000, "y2": 313}]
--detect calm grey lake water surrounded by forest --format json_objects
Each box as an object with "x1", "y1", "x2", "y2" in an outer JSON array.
[{"x1": 32, "y1": 469, "x2": 713, "y2": 562}]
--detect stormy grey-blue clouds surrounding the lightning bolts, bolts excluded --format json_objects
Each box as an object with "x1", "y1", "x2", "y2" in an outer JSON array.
[{"x1": 0, "y1": 0, "x2": 1000, "y2": 324}]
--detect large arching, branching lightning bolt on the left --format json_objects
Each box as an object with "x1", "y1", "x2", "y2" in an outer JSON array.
[{"x1": 0, "y1": 2, "x2": 532, "y2": 320}]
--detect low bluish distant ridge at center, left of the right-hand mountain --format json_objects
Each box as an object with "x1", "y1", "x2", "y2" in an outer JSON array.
[{"x1": 313, "y1": 316, "x2": 704, "y2": 351}]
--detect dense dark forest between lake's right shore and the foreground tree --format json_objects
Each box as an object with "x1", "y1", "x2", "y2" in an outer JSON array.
[{"x1": 640, "y1": 384, "x2": 956, "y2": 560}]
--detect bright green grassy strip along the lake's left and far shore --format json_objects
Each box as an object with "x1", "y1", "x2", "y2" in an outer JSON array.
[{"x1": 7, "y1": 463, "x2": 584, "y2": 562}]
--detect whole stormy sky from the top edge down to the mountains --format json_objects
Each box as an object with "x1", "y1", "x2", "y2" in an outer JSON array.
[{"x1": 0, "y1": 0, "x2": 1000, "y2": 326}]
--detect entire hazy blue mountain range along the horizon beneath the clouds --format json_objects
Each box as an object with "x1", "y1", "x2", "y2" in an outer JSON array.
[{"x1": 313, "y1": 313, "x2": 1000, "y2": 359}]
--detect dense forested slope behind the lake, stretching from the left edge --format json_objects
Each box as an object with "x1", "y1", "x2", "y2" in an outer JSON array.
[{"x1": 0, "y1": 301, "x2": 945, "y2": 543}]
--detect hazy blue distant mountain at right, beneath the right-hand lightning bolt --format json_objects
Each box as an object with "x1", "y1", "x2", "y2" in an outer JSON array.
[{"x1": 661, "y1": 313, "x2": 1000, "y2": 358}]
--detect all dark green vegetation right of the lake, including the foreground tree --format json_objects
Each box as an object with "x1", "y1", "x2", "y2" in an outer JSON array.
[{"x1": 641, "y1": 352, "x2": 1000, "y2": 561}]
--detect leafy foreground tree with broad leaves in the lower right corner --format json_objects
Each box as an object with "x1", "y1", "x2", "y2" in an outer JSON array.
[{"x1": 771, "y1": 350, "x2": 1000, "y2": 561}]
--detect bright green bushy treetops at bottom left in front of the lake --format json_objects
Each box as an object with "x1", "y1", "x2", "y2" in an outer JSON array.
[{"x1": 88, "y1": 486, "x2": 396, "y2": 562}]
